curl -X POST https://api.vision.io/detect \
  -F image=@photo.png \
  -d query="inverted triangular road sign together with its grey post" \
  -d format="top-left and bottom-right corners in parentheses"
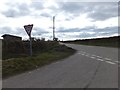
top-left (24, 24), bottom-right (33, 56)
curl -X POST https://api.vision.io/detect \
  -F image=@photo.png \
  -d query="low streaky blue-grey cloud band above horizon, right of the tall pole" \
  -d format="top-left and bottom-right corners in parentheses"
top-left (56, 27), bottom-right (118, 39)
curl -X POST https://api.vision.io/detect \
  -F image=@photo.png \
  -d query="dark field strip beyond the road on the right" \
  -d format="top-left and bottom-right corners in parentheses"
top-left (64, 36), bottom-right (120, 48)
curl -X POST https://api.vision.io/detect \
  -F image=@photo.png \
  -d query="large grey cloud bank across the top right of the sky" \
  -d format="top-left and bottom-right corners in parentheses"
top-left (59, 2), bottom-right (118, 21)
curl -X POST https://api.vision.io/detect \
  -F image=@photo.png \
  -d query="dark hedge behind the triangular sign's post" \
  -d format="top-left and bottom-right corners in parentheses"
top-left (2, 39), bottom-right (58, 60)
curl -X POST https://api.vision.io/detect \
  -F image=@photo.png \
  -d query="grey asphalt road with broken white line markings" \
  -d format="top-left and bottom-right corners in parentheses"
top-left (3, 44), bottom-right (119, 89)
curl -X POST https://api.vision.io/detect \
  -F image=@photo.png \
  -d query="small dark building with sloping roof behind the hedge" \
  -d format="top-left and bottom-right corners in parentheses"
top-left (2, 34), bottom-right (22, 41)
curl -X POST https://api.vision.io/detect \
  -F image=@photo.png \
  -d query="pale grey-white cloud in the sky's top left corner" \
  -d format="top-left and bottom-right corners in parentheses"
top-left (2, 0), bottom-right (43, 18)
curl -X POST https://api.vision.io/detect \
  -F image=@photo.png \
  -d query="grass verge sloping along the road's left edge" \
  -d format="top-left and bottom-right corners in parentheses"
top-left (2, 45), bottom-right (75, 78)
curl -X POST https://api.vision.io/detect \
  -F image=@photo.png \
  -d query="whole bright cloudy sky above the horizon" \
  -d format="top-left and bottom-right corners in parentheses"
top-left (0, 0), bottom-right (118, 40)
